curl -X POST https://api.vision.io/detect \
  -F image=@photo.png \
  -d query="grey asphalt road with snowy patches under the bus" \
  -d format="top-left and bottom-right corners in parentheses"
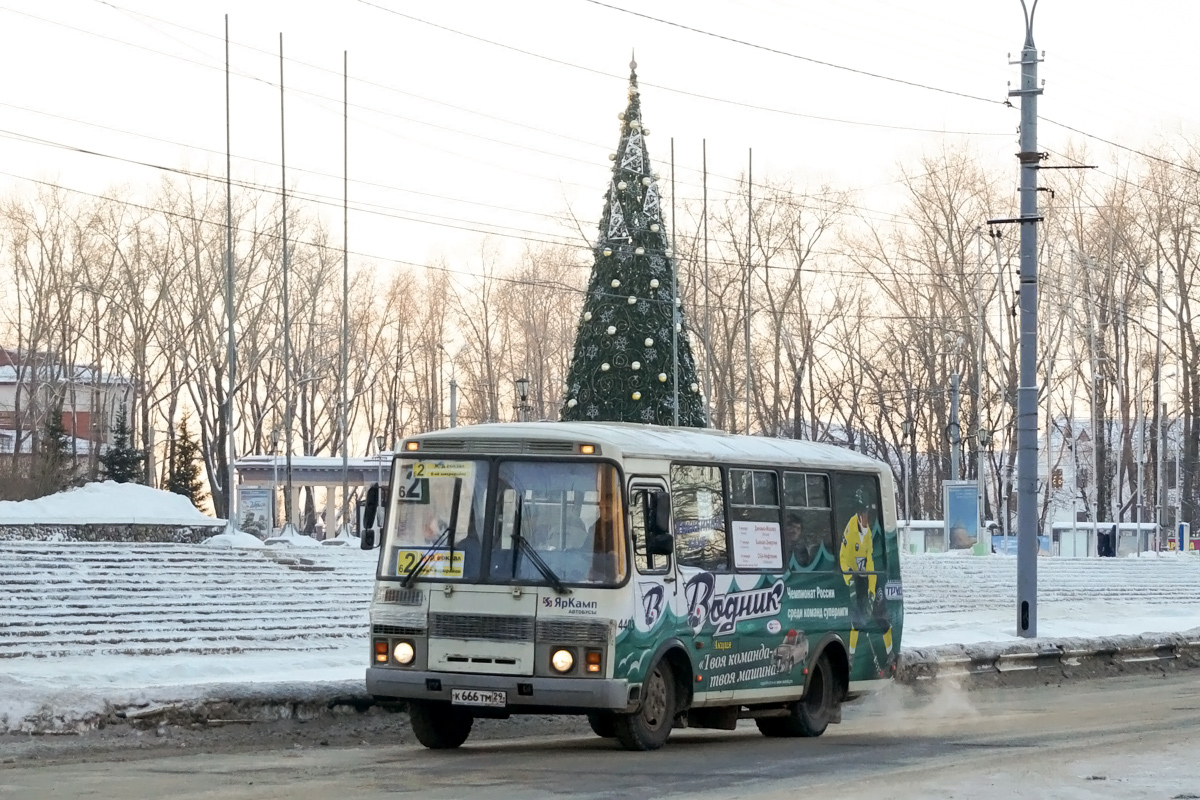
top-left (0, 674), bottom-right (1200, 800)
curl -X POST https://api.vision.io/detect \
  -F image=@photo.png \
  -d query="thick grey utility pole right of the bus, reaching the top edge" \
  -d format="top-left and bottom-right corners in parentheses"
top-left (1008, 0), bottom-right (1042, 638)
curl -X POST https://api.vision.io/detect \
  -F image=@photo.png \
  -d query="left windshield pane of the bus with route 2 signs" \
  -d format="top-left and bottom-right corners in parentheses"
top-left (379, 458), bottom-right (488, 581)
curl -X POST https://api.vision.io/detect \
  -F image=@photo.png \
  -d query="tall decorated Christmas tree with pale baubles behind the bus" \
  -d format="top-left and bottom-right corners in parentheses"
top-left (562, 64), bottom-right (706, 427)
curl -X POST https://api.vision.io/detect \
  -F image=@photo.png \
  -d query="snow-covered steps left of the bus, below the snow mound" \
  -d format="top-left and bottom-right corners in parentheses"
top-left (0, 542), bottom-right (376, 663)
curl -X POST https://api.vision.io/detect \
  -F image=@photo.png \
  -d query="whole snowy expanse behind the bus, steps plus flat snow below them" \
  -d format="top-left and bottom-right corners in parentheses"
top-left (0, 541), bottom-right (1200, 730)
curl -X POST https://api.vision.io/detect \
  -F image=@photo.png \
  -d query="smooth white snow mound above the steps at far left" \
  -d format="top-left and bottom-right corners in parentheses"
top-left (0, 481), bottom-right (224, 527)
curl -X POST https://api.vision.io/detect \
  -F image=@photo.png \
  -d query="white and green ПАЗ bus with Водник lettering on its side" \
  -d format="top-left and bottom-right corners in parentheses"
top-left (362, 422), bottom-right (904, 751)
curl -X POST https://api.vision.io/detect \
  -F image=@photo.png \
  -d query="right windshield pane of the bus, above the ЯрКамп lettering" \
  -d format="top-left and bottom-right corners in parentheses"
top-left (488, 461), bottom-right (626, 585)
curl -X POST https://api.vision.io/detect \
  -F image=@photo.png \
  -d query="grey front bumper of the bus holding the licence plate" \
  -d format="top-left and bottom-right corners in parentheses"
top-left (367, 667), bottom-right (638, 711)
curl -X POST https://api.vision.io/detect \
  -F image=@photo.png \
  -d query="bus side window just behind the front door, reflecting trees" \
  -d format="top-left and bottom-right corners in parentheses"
top-left (671, 464), bottom-right (730, 572)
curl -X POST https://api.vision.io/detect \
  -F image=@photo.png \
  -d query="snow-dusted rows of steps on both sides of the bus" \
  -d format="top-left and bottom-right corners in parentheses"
top-left (0, 542), bottom-right (1200, 673)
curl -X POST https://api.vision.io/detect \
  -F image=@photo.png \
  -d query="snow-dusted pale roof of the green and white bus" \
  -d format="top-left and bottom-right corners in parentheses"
top-left (408, 422), bottom-right (888, 471)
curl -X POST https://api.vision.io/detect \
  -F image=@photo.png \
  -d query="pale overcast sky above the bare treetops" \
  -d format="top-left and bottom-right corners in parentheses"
top-left (0, 0), bottom-right (1200, 272)
